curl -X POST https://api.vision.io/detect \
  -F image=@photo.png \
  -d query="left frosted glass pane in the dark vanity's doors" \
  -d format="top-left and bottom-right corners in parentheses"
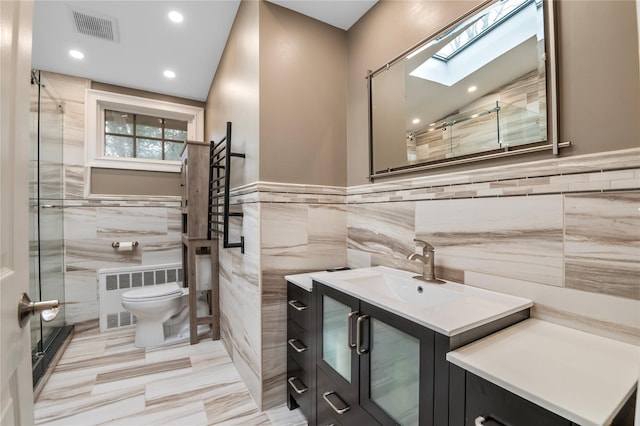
top-left (322, 294), bottom-right (351, 383)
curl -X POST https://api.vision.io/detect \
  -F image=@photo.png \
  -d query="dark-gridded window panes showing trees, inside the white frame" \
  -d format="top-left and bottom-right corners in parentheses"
top-left (104, 109), bottom-right (187, 161)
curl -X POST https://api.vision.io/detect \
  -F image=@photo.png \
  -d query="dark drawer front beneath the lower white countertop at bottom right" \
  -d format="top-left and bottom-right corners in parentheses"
top-left (465, 372), bottom-right (572, 426)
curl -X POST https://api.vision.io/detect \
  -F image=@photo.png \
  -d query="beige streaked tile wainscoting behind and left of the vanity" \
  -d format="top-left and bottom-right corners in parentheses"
top-left (221, 149), bottom-right (640, 409)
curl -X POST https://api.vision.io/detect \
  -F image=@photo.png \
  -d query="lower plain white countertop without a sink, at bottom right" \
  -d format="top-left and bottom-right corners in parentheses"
top-left (447, 319), bottom-right (640, 425)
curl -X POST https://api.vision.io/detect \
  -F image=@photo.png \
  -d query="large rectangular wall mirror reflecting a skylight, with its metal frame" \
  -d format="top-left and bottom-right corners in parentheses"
top-left (368, 0), bottom-right (559, 179)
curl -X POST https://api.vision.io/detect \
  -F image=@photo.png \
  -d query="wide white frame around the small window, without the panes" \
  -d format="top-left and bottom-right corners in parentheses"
top-left (85, 89), bottom-right (204, 173)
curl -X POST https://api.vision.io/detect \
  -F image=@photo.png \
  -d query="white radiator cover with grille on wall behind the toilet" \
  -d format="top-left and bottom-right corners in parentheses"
top-left (98, 263), bottom-right (182, 331)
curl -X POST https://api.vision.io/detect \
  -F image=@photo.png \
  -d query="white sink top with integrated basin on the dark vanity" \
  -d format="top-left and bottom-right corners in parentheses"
top-left (311, 266), bottom-right (533, 336)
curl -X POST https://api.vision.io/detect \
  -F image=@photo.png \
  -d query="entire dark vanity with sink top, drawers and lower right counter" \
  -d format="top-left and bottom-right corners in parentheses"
top-left (287, 267), bottom-right (640, 426)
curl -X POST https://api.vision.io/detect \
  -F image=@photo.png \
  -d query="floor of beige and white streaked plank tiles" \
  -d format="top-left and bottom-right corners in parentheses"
top-left (35, 324), bottom-right (307, 426)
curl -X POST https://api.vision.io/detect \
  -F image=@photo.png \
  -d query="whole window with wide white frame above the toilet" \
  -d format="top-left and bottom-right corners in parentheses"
top-left (85, 89), bottom-right (204, 172)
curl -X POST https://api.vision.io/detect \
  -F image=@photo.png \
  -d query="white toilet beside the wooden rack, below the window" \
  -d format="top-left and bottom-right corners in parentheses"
top-left (121, 282), bottom-right (209, 348)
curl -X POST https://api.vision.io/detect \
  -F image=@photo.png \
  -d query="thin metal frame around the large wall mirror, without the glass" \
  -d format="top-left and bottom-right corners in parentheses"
top-left (365, 0), bottom-right (571, 182)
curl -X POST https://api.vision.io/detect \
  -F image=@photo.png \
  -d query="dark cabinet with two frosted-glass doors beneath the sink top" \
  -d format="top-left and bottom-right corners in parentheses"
top-left (314, 282), bottom-right (529, 426)
